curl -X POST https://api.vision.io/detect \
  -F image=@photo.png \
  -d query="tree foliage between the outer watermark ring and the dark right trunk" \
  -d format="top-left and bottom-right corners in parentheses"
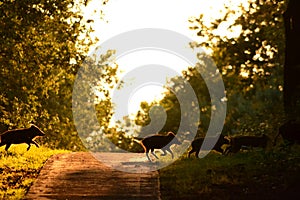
top-left (191, 0), bottom-right (286, 134)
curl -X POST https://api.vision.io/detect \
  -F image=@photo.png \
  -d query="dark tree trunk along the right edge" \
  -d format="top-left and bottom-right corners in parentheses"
top-left (284, 0), bottom-right (300, 119)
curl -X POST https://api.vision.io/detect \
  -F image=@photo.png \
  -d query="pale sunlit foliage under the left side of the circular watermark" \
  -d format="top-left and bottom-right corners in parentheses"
top-left (73, 50), bottom-right (133, 151)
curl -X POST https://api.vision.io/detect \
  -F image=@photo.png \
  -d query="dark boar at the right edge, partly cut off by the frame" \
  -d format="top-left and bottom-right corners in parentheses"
top-left (274, 120), bottom-right (300, 145)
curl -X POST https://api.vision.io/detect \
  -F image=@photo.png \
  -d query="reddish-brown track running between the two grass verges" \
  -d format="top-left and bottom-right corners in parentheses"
top-left (26, 152), bottom-right (160, 200)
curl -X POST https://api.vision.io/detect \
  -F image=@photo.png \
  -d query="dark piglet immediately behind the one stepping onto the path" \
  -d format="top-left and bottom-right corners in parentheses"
top-left (188, 134), bottom-right (229, 158)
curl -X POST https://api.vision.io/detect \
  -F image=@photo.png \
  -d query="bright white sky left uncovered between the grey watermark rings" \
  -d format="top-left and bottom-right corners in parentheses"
top-left (84, 0), bottom-right (247, 121)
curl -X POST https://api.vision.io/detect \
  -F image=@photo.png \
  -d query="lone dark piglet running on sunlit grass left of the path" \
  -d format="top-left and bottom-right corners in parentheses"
top-left (0, 124), bottom-right (45, 151)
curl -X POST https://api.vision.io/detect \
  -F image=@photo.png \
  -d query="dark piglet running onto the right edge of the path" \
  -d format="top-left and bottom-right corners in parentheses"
top-left (141, 132), bottom-right (181, 162)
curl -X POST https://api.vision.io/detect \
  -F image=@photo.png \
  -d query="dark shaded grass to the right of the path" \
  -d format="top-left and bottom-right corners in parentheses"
top-left (159, 145), bottom-right (300, 200)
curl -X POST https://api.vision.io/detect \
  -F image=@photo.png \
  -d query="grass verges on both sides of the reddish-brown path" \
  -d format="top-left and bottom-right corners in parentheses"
top-left (0, 142), bottom-right (300, 200)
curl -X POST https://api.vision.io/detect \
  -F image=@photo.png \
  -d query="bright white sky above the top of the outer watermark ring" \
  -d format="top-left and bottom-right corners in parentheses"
top-left (84, 0), bottom-right (248, 41)
